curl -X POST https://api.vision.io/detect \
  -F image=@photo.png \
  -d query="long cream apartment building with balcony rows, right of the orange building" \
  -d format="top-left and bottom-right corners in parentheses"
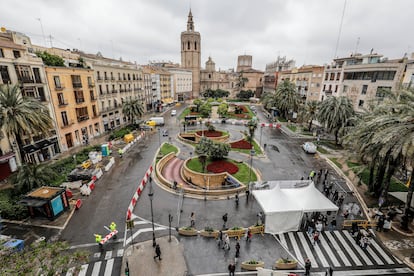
top-left (80, 52), bottom-right (145, 132)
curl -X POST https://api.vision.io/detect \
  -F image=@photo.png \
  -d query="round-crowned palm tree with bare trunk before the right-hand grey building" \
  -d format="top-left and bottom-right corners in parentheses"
top-left (317, 96), bottom-right (355, 145)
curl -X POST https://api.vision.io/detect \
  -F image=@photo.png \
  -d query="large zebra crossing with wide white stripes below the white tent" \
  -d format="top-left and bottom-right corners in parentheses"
top-left (274, 230), bottom-right (404, 270)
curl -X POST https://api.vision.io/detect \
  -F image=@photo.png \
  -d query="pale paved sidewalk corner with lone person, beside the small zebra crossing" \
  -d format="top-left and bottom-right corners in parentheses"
top-left (121, 236), bottom-right (188, 276)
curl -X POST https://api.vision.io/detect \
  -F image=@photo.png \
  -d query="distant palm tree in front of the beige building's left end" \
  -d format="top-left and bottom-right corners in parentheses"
top-left (272, 80), bottom-right (300, 119)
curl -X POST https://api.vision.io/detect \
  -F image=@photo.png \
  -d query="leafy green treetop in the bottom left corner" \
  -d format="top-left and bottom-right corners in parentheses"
top-left (0, 241), bottom-right (88, 276)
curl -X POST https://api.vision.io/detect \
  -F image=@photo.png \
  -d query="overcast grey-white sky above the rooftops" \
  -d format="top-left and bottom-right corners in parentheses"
top-left (0, 0), bottom-right (414, 70)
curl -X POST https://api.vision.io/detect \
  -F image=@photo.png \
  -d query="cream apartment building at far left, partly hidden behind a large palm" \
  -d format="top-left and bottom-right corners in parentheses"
top-left (0, 28), bottom-right (60, 174)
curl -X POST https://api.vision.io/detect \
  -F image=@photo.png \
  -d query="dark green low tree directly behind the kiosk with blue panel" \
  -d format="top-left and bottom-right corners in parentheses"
top-left (10, 163), bottom-right (56, 194)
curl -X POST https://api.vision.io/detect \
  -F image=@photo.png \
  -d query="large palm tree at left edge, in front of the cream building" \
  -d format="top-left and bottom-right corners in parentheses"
top-left (0, 85), bottom-right (52, 164)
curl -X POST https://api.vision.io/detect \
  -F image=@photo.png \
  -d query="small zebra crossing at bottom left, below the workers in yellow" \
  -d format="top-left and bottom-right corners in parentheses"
top-left (66, 249), bottom-right (124, 276)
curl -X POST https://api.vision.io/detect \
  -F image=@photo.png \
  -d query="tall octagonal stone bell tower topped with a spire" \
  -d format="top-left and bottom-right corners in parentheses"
top-left (181, 10), bottom-right (201, 99)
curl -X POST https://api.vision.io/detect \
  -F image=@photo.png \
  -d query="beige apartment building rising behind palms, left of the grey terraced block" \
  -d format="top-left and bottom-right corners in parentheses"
top-left (277, 65), bottom-right (324, 102)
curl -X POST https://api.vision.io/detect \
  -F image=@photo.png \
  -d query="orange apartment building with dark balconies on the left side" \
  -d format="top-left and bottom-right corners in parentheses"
top-left (46, 66), bottom-right (102, 151)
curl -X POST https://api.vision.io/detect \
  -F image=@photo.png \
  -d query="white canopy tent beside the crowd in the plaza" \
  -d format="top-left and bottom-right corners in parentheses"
top-left (253, 181), bottom-right (338, 234)
